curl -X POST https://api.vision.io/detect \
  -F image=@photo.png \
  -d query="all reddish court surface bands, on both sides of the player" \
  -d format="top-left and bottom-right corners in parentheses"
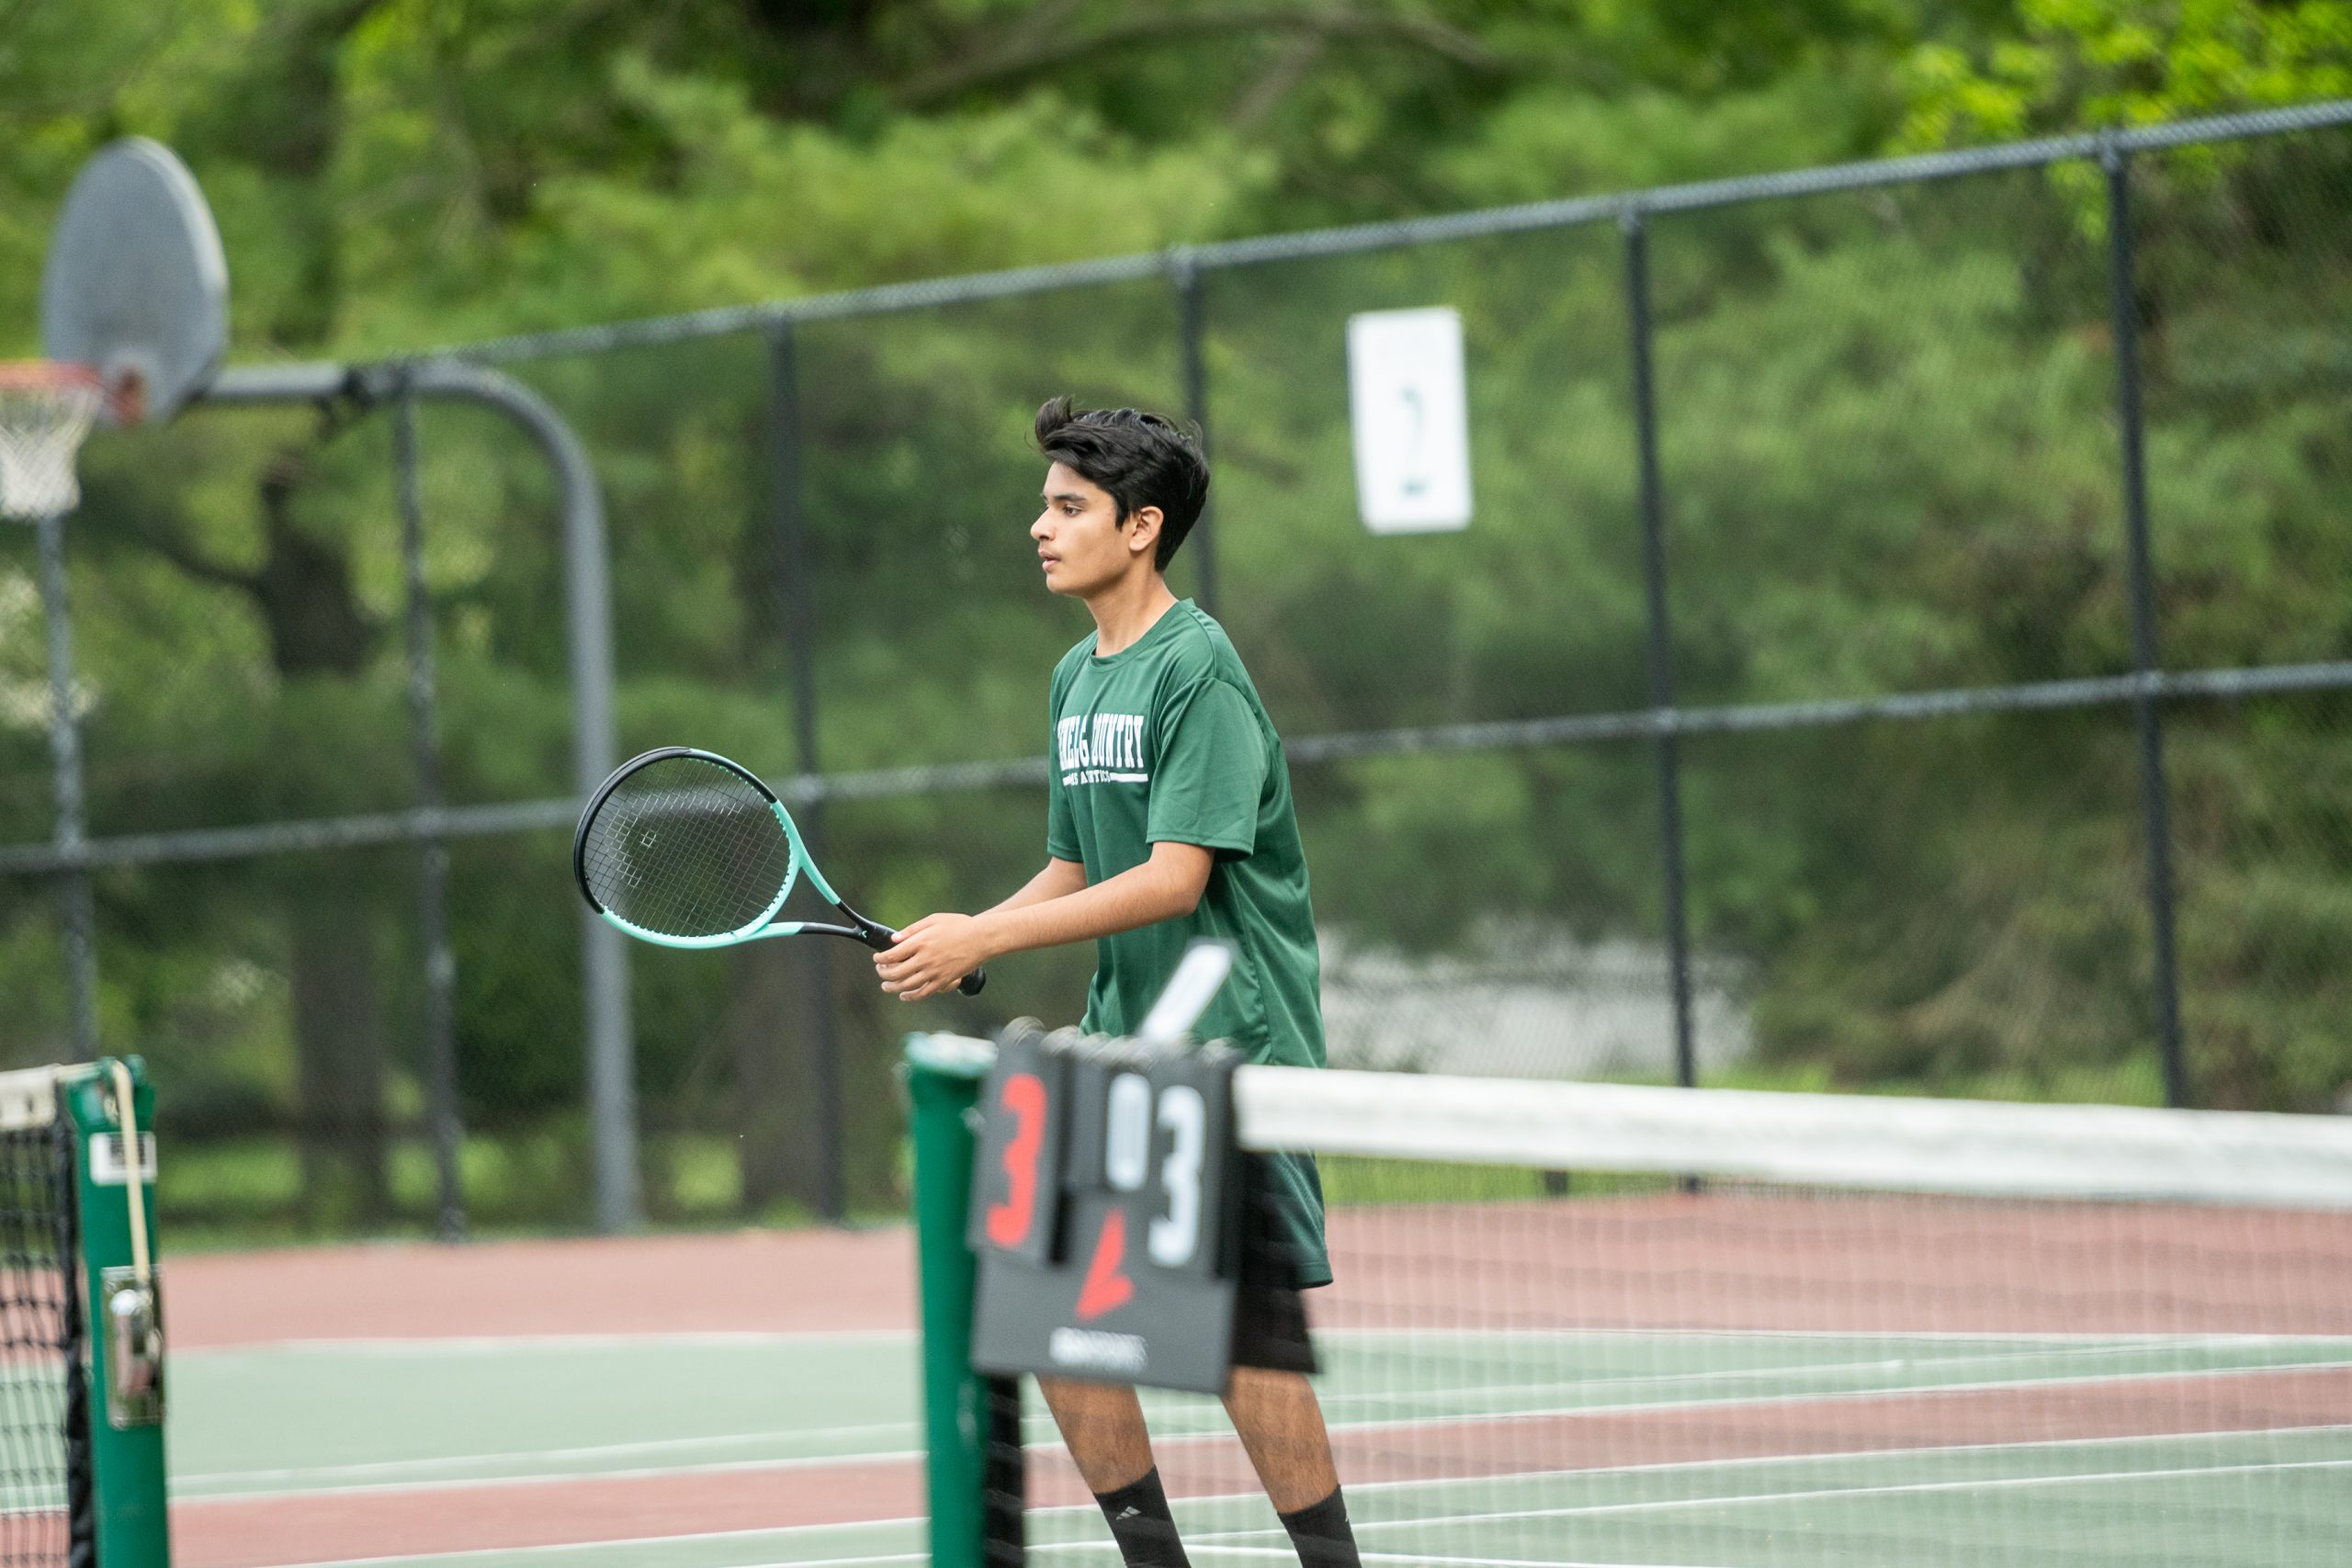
top-left (169, 1194), bottom-right (2352, 1568)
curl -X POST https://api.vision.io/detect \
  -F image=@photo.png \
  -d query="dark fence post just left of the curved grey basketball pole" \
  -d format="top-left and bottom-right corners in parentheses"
top-left (390, 376), bottom-right (466, 1241)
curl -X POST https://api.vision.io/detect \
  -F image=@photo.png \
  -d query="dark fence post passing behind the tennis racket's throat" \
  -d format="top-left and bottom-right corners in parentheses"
top-left (767, 322), bottom-right (849, 1224)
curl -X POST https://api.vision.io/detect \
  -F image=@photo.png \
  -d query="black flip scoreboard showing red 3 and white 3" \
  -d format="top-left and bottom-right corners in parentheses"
top-left (969, 1025), bottom-right (1242, 1394)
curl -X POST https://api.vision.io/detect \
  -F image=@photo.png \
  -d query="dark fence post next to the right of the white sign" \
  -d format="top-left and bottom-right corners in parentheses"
top-left (1623, 207), bottom-right (1698, 1089)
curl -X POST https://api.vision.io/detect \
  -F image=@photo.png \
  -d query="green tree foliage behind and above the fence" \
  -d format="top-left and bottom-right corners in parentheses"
top-left (0, 0), bottom-right (2352, 1224)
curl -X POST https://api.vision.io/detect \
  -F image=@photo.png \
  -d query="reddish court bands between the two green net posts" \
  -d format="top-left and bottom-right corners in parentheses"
top-left (169, 1227), bottom-right (922, 1568)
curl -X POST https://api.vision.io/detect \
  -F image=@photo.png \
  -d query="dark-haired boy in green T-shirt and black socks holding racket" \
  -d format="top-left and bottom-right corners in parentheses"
top-left (875, 398), bottom-right (1360, 1568)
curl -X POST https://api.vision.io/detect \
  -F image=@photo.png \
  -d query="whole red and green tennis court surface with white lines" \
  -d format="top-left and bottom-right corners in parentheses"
top-left (172, 1128), bottom-right (2352, 1568)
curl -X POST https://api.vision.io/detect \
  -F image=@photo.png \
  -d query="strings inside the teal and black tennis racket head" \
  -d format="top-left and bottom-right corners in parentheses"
top-left (581, 757), bottom-right (795, 938)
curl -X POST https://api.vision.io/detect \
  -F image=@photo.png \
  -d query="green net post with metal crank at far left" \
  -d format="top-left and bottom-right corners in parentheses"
top-left (59, 1055), bottom-right (172, 1568)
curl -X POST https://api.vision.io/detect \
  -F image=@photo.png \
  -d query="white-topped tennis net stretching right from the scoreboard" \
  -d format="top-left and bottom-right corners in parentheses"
top-left (922, 1043), bottom-right (2352, 1568)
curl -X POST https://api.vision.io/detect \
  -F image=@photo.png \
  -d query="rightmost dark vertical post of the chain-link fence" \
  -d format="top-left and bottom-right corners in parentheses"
top-left (2098, 141), bottom-right (2189, 1105)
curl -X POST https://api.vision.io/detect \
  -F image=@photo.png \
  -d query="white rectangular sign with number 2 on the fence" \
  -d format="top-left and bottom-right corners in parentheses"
top-left (1348, 306), bottom-right (1470, 534)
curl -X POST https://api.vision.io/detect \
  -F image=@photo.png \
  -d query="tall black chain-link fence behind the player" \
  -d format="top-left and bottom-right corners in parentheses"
top-left (0, 104), bottom-right (2352, 1236)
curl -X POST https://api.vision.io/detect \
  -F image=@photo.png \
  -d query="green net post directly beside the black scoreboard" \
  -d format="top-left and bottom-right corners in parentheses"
top-left (906, 1034), bottom-right (990, 1568)
